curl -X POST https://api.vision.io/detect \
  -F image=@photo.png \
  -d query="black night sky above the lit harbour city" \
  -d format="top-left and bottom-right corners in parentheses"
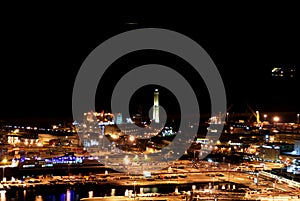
top-left (0, 6), bottom-right (300, 124)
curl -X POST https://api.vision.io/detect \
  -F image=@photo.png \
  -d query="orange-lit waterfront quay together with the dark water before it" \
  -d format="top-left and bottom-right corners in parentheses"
top-left (1, 161), bottom-right (299, 201)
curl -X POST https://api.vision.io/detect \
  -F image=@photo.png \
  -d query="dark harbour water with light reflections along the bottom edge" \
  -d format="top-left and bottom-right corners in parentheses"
top-left (0, 182), bottom-right (245, 201)
